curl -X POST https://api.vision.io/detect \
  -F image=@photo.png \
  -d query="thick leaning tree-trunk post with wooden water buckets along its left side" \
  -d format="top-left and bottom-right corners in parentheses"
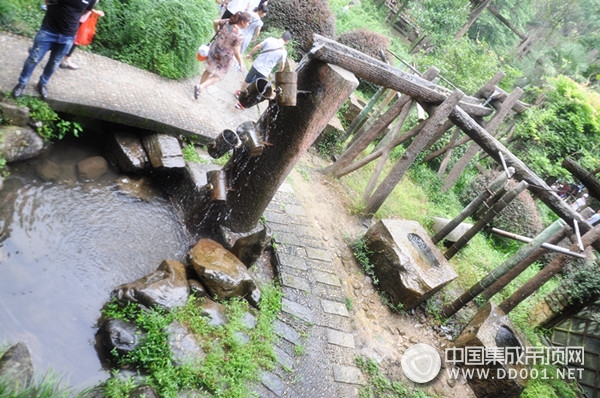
top-left (202, 58), bottom-right (358, 236)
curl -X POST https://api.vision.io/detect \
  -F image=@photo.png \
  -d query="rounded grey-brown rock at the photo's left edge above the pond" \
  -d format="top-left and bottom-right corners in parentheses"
top-left (0, 126), bottom-right (44, 163)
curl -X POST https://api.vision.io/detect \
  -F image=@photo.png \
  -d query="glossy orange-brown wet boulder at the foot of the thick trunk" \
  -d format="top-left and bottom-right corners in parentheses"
top-left (189, 239), bottom-right (257, 300)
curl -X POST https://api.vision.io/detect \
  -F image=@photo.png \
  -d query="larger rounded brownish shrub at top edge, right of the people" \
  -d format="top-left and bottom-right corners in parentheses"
top-left (265, 0), bottom-right (335, 52)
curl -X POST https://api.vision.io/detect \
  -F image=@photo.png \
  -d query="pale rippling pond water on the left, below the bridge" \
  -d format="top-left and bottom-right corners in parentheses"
top-left (0, 134), bottom-right (188, 388)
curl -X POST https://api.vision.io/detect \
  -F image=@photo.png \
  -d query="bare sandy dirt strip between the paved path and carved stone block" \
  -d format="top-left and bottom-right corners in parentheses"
top-left (288, 153), bottom-right (474, 398)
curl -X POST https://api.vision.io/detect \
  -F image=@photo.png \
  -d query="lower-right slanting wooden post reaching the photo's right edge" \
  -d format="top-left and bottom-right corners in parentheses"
top-left (500, 225), bottom-right (600, 314)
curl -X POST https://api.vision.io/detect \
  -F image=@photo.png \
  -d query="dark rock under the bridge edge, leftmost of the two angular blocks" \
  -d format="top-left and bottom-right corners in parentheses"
top-left (108, 132), bottom-right (150, 173)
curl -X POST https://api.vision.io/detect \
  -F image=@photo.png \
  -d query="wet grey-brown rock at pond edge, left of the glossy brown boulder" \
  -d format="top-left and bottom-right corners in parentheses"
top-left (111, 260), bottom-right (189, 310)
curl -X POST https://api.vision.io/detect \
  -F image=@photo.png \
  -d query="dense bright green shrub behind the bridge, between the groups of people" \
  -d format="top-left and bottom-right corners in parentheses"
top-left (92, 0), bottom-right (218, 79)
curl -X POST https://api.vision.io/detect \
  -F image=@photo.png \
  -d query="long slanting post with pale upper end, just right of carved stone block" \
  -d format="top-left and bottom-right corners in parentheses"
top-left (442, 219), bottom-right (566, 318)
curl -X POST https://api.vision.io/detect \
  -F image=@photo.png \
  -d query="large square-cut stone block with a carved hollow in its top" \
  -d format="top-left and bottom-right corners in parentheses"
top-left (365, 220), bottom-right (457, 310)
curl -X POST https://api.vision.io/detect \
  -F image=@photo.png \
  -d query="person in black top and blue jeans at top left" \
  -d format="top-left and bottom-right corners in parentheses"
top-left (12, 0), bottom-right (96, 99)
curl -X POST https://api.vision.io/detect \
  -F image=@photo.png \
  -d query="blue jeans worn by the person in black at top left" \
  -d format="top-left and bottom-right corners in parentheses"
top-left (19, 29), bottom-right (75, 86)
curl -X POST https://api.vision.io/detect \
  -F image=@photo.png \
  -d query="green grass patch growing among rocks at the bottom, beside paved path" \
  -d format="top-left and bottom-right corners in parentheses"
top-left (98, 285), bottom-right (281, 398)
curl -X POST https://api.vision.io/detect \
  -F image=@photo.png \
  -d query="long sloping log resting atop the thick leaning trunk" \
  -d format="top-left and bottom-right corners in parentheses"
top-left (308, 34), bottom-right (492, 117)
